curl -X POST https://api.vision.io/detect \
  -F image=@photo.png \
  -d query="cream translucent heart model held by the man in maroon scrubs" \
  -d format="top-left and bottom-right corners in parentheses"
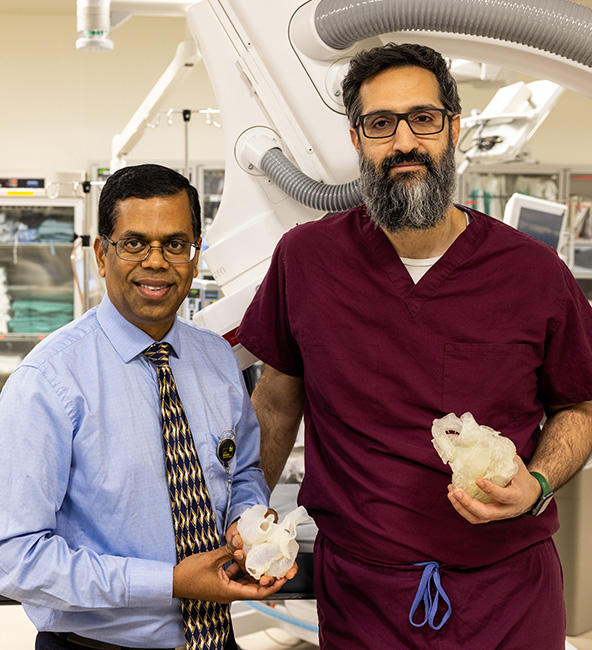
top-left (432, 413), bottom-right (518, 503)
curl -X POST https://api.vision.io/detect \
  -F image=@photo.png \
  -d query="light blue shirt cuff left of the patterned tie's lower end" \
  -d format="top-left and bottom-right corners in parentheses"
top-left (127, 558), bottom-right (173, 607)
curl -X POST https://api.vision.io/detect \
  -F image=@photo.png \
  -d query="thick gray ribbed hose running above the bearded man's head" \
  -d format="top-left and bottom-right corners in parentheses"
top-left (315, 0), bottom-right (592, 67)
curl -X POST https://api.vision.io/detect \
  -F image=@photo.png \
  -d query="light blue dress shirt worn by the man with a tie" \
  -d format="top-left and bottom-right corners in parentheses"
top-left (0, 297), bottom-right (269, 648)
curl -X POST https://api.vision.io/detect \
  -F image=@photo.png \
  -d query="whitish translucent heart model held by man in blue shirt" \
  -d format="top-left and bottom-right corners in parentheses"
top-left (238, 505), bottom-right (308, 580)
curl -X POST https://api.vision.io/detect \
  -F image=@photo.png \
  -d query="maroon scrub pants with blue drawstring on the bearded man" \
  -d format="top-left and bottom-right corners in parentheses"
top-left (314, 533), bottom-right (565, 650)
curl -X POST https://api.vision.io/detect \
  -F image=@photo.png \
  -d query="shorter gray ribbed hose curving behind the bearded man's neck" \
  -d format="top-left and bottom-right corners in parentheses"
top-left (261, 148), bottom-right (362, 212)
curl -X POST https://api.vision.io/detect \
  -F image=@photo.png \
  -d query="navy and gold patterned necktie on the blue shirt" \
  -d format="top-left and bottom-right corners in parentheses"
top-left (144, 343), bottom-right (230, 650)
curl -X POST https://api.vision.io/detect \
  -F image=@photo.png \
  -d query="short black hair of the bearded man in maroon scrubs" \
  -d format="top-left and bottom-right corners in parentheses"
top-left (343, 43), bottom-right (461, 128)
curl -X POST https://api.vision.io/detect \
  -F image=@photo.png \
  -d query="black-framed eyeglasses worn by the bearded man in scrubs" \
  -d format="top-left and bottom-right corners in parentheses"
top-left (358, 108), bottom-right (452, 138)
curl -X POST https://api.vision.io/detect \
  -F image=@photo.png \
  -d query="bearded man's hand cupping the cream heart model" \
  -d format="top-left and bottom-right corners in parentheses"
top-left (448, 456), bottom-right (541, 524)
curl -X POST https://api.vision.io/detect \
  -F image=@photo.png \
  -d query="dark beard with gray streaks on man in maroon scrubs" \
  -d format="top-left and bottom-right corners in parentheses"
top-left (358, 141), bottom-right (456, 233)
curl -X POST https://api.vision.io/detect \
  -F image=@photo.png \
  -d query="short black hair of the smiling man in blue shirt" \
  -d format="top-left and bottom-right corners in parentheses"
top-left (99, 164), bottom-right (201, 242)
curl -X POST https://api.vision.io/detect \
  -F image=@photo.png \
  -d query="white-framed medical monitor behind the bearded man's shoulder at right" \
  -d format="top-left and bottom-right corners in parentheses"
top-left (504, 193), bottom-right (567, 251)
